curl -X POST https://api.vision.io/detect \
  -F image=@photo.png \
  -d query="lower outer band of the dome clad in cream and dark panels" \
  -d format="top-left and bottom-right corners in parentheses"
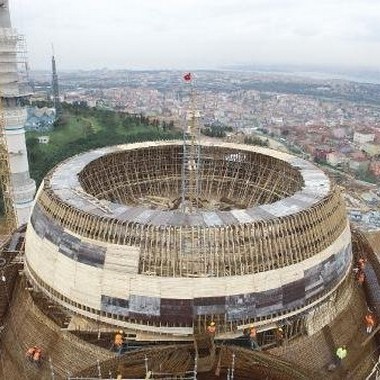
top-left (26, 202), bottom-right (352, 336)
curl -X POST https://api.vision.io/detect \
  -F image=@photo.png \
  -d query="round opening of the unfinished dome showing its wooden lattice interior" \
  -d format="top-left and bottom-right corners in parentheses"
top-left (78, 145), bottom-right (304, 211)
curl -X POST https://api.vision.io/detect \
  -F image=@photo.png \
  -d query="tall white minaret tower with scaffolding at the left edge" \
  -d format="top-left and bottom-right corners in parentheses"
top-left (0, 0), bottom-right (36, 226)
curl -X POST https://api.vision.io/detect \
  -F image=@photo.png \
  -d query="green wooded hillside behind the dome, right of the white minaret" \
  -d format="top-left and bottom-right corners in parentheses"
top-left (26, 105), bottom-right (181, 185)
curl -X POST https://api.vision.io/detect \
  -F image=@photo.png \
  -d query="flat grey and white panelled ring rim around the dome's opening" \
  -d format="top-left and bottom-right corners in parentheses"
top-left (45, 141), bottom-right (331, 227)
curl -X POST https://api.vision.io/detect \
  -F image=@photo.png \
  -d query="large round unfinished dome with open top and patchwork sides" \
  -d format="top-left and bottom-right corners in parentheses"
top-left (25, 141), bottom-right (352, 339)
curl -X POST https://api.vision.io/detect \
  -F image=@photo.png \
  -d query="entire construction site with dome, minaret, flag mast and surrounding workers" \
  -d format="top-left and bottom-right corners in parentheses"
top-left (0, 1), bottom-right (380, 380)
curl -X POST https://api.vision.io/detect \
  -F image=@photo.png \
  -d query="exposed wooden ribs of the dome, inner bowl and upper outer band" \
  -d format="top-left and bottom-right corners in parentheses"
top-left (34, 145), bottom-right (347, 277)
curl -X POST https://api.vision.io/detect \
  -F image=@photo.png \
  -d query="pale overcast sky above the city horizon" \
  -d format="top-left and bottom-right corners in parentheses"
top-left (10, 0), bottom-right (380, 69)
